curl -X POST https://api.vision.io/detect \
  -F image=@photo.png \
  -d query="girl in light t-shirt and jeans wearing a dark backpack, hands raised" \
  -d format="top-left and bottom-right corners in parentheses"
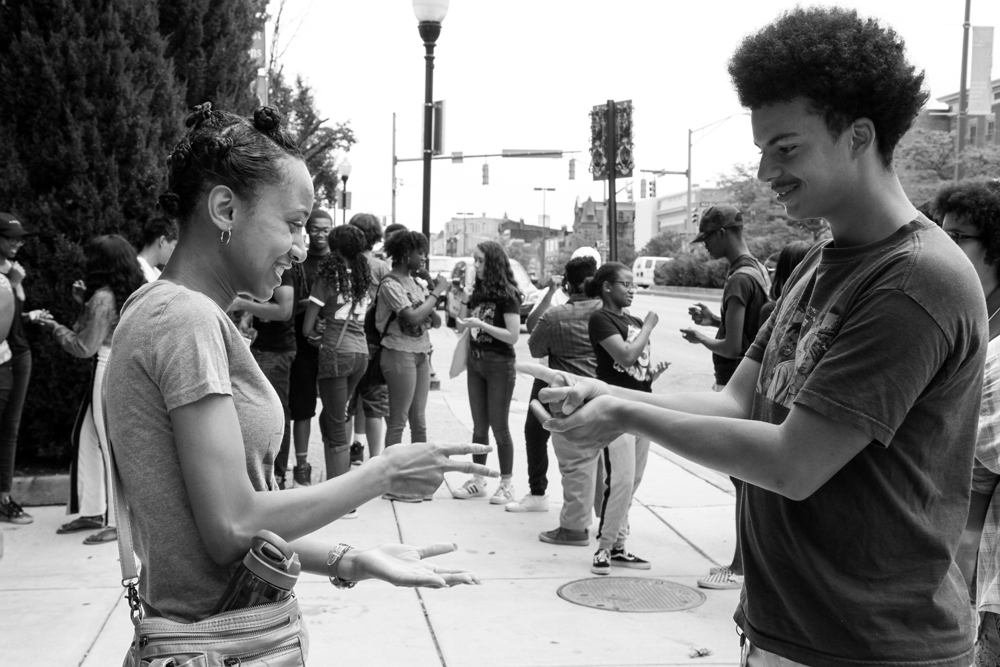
top-left (375, 231), bottom-right (448, 482)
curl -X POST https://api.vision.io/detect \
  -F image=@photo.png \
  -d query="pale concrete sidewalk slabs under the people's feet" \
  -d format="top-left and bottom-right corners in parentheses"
top-left (0, 332), bottom-right (739, 667)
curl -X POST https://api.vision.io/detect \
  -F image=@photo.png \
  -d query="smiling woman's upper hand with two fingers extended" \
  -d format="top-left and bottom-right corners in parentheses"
top-left (374, 442), bottom-right (500, 495)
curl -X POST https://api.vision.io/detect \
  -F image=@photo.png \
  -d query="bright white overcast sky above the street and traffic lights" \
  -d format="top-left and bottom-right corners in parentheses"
top-left (269, 0), bottom-right (1000, 232)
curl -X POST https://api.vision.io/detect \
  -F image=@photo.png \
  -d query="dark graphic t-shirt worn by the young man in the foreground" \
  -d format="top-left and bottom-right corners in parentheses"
top-left (735, 216), bottom-right (988, 667)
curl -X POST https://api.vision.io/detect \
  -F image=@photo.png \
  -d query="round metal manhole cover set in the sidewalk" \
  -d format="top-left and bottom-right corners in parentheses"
top-left (558, 577), bottom-right (705, 612)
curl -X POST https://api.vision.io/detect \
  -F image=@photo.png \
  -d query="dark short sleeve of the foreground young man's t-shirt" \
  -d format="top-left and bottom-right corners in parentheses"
top-left (796, 289), bottom-right (952, 446)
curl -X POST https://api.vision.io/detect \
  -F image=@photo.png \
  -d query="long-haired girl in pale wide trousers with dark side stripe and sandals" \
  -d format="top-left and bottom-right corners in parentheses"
top-left (38, 234), bottom-right (146, 544)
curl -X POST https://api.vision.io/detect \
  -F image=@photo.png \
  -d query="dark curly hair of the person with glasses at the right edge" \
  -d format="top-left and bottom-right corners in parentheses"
top-left (932, 178), bottom-right (1000, 277)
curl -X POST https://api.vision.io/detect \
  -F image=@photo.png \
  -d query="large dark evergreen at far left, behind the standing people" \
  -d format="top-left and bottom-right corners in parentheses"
top-left (0, 0), bottom-right (181, 457)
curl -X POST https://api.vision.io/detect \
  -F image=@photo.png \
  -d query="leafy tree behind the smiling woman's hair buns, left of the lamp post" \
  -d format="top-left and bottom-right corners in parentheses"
top-left (268, 70), bottom-right (356, 208)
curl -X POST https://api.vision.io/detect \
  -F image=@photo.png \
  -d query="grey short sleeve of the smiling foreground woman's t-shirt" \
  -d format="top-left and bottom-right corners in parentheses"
top-left (151, 296), bottom-right (234, 411)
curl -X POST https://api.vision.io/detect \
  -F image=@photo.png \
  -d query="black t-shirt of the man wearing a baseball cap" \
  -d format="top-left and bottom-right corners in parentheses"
top-left (712, 255), bottom-right (770, 385)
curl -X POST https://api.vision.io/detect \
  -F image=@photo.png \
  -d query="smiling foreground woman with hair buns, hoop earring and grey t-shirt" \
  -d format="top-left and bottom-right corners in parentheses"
top-left (105, 104), bottom-right (494, 636)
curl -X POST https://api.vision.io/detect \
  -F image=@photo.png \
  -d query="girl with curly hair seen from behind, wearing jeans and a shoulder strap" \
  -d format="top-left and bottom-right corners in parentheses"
top-left (302, 225), bottom-right (372, 490)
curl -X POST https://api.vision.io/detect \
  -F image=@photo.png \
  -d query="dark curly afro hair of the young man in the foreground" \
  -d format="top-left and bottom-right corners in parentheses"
top-left (729, 7), bottom-right (929, 169)
